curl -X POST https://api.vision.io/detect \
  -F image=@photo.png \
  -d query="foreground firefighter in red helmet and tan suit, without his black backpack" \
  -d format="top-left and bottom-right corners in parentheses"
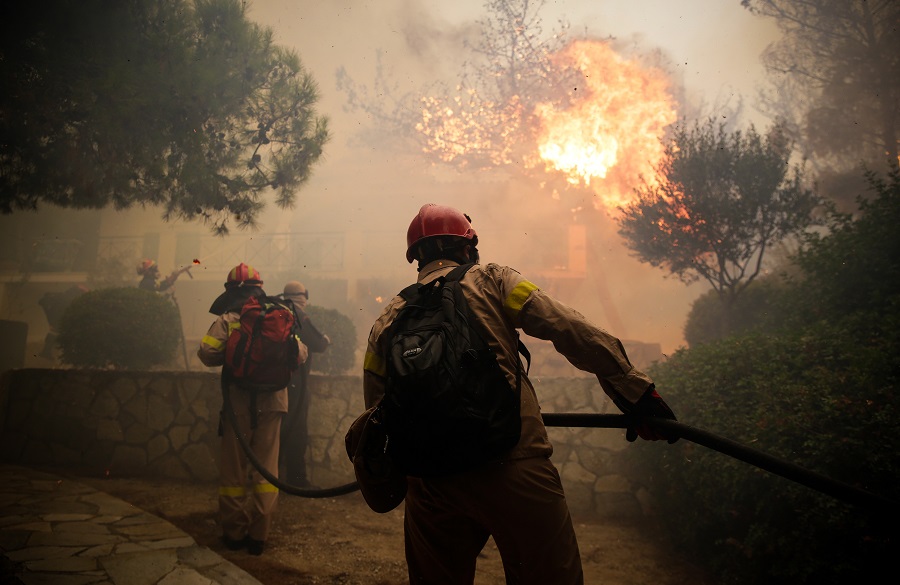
top-left (363, 204), bottom-right (676, 585)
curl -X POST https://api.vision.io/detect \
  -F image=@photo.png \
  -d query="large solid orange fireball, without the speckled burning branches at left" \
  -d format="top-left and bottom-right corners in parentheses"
top-left (535, 41), bottom-right (677, 208)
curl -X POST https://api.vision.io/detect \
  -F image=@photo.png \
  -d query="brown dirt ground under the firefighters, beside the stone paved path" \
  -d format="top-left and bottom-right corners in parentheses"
top-left (73, 477), bottom-right (714, 585)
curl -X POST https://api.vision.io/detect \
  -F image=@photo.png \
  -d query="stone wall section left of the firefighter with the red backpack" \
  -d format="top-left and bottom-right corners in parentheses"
top-left (0, 369), bottom-right (221, 481)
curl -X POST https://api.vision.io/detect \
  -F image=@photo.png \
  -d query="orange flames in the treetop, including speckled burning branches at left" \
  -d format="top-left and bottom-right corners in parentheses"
top-left (416, 40), bottom-right (677, 210)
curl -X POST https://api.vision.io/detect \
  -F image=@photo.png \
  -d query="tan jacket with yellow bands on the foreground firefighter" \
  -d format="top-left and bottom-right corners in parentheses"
top-left (363, 260), bottom-right (652, 459)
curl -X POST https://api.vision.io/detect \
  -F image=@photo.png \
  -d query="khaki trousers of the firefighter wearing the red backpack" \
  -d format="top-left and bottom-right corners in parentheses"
top-left (219, 409), bottom-right (284, 541)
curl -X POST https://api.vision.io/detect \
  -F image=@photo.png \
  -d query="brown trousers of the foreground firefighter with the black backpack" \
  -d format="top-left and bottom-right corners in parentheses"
top-left (404, 457), bottom-right (584, 585)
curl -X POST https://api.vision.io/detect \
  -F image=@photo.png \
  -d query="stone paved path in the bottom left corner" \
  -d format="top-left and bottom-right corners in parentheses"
top-left (0, 465), bottom-right (261, 585)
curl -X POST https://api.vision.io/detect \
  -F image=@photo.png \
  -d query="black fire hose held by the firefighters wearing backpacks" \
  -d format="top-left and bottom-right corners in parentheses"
top-left (222, 384), bottom-right (900, 518)
